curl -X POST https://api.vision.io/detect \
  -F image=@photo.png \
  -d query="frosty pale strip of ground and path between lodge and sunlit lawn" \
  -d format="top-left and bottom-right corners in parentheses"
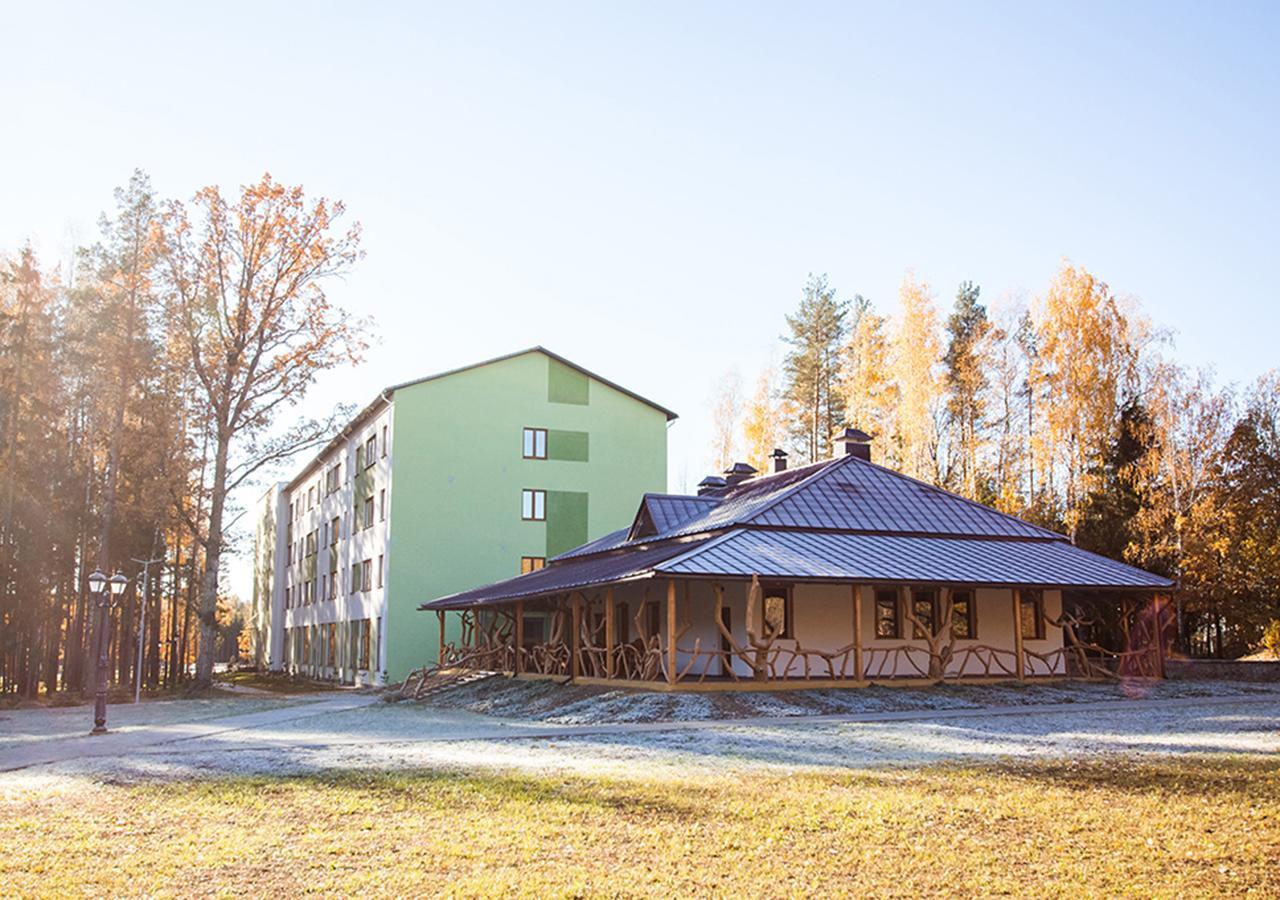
top-left (0, 685), bottom-right (1280, 794)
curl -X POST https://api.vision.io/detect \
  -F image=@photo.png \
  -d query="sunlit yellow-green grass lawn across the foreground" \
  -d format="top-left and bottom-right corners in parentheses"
top-left (0, 758), bottom-right (1280, 896)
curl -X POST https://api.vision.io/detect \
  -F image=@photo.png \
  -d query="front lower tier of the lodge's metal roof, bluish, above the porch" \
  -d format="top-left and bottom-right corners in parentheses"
top-left (654, 529), bottom-right (1172, 590)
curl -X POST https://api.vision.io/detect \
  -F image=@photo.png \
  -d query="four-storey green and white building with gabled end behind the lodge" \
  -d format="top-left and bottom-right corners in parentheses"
top-left (253, 347), bottom-right (676, 684)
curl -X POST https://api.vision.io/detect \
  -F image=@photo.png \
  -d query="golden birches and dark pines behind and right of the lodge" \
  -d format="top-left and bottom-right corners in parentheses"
top-left (713, 262), bottom-right (1280, 657)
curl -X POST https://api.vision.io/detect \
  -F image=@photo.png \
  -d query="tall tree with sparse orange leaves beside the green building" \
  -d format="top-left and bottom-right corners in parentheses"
top-left (161, 174), bottom-right (367, 685)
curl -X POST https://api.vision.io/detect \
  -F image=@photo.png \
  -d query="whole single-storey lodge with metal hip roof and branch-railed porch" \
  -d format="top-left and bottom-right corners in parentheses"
top-left (422, 429), bottom-right (1172, 690)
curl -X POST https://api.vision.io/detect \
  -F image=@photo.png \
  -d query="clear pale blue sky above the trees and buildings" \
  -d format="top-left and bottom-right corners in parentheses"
top-left (0, 3), bottom-right (1280, 599)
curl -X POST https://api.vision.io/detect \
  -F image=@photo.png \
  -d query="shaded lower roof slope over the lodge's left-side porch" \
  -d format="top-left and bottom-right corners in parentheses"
top-left (419, 538), bottom-right (709, 609)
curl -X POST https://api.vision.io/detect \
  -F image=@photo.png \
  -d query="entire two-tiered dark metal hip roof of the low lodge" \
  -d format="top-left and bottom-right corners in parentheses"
top-left (422, 454), bottom-right (1172, 609)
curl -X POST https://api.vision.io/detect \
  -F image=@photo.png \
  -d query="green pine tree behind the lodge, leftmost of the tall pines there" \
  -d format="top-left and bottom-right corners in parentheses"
top-left (783, 275), bottom-right (847, 462)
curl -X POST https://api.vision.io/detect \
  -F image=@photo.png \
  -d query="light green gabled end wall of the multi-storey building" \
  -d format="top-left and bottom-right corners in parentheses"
top-left (384, 352), bottom-right (667, 681)
